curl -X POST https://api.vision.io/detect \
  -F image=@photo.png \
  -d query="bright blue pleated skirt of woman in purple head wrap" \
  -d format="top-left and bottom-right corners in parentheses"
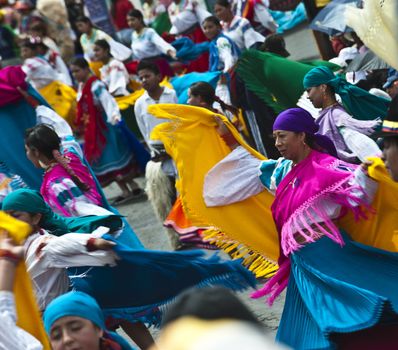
top-left (277, 232), bottom-right (398, 349)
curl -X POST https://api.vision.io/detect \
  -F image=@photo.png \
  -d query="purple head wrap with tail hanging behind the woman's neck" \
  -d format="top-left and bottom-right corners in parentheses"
top-left (272, 108), bottom-right (337, 158)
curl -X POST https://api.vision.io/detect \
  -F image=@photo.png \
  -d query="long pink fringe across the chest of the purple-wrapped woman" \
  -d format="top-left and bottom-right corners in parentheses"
top-left (281, 176), bottom-right (371, 256)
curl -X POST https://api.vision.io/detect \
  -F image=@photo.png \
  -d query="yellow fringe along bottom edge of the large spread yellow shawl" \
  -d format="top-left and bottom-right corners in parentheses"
top-left (201, 228), bottom-right (278, 278)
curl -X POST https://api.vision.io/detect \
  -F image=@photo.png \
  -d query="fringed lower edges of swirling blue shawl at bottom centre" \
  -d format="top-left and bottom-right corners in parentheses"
top-left (102, 271), bottom-right (254, 328)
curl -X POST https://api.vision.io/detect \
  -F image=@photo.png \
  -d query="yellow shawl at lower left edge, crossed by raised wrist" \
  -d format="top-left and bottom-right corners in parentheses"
top-left (0, 211), bottom-right (51, 350)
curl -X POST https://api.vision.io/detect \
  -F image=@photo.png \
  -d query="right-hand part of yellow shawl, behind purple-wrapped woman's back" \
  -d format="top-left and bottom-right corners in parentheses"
top-left (339, 158), bottom-right (398, 252)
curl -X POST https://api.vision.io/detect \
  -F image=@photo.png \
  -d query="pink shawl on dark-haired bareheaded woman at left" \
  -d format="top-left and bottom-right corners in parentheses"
top-left (40, 152), bottom-right (103, 216)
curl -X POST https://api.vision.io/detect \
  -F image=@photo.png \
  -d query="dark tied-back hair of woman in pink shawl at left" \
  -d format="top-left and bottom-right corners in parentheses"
top-left (25, 124), bottom-right (90, 192)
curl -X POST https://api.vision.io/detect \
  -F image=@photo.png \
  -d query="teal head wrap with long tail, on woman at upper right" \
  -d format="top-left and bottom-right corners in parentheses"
top-left (303, 66), bottom-right (389, 120)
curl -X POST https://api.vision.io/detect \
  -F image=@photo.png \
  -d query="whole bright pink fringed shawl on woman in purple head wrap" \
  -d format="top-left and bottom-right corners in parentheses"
top-left (252, 151), bottom-right (367, 304)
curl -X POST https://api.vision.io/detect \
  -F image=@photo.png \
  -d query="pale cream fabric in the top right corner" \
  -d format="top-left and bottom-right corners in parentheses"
top-left (342, 0), bottom-right (398, 69)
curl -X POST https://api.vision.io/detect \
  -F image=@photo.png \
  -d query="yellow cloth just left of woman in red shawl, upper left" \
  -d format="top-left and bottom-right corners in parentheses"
top-left (39, 81), bottom-right (77, 128)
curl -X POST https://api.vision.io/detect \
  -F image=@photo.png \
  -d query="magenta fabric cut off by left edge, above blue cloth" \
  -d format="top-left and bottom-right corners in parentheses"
top-left (0, 66), bottom-right (28, 107)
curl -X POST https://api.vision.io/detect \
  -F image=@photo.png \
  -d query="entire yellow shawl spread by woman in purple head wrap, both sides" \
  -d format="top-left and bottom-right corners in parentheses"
top-left (148, 104), bottom-right (398, 277)
